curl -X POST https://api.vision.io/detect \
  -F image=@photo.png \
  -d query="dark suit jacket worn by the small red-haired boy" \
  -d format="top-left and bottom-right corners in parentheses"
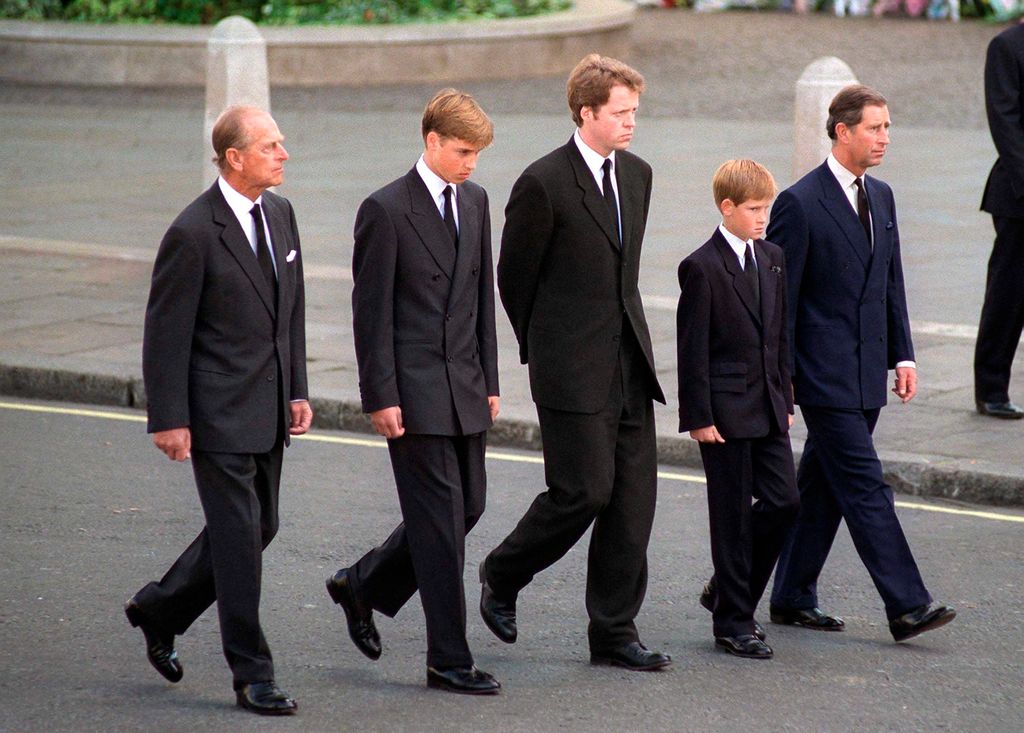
top-left (676, 229), bottom-right (793, 440)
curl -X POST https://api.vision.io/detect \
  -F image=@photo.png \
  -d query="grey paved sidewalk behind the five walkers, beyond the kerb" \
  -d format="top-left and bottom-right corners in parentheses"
top-left (0, 12), bottom-right (1024, 505)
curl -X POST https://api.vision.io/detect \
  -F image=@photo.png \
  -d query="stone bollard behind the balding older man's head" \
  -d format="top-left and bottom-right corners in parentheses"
top-left (203, 15), bottom-right (270, 188)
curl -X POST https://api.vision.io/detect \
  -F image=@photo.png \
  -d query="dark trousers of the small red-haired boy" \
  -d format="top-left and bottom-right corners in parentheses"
top-left (700, 433), bottom-right (800, 637)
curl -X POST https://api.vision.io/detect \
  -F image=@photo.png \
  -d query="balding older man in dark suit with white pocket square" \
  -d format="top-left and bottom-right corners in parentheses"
top-left (125, 106), bottom-right (312, 715)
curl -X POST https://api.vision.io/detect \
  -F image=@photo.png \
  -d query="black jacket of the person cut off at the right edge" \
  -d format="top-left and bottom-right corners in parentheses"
top-left (981, 25), bottom-right (1024, 219)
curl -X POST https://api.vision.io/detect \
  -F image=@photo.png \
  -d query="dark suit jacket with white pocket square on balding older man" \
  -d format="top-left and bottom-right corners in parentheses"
top-left (142, 182), bottom-right (308, 454)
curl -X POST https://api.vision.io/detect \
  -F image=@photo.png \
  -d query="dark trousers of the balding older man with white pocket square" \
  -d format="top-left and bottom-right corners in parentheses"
top-left (135, 437), bottom-right (284, 689)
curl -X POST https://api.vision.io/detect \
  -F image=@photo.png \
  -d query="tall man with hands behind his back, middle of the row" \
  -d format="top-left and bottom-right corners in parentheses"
top-left (480, 53), bottom-right (671, 670)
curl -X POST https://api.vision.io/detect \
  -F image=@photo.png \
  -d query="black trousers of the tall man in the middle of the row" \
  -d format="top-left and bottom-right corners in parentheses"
top-left (484, 329), bottom-right (657, 651)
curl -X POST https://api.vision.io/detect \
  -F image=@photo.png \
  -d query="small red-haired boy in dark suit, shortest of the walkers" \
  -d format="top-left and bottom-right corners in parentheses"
top-left (676, 160), bottom-right (800, 659)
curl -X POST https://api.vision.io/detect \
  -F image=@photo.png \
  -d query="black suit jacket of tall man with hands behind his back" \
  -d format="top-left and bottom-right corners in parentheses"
top-left (498, 139), bottom-right (665, 413)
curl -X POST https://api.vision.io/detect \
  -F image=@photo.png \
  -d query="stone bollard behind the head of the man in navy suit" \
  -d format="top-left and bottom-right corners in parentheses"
top-left (793, 56), bottom-right (857, 179)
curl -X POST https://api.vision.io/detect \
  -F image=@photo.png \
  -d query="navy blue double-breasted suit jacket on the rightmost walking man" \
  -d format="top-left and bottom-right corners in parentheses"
top-left (767, 163), bottom-right (913, 409)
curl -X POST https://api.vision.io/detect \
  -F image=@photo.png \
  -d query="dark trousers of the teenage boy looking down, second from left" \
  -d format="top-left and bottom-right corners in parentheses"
top-left (350, 433), bottom-right (486, 666)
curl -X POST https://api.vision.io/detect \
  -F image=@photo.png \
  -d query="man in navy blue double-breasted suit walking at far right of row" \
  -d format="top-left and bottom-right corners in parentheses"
top-left (768, 84), bottom-right (956, 642)
